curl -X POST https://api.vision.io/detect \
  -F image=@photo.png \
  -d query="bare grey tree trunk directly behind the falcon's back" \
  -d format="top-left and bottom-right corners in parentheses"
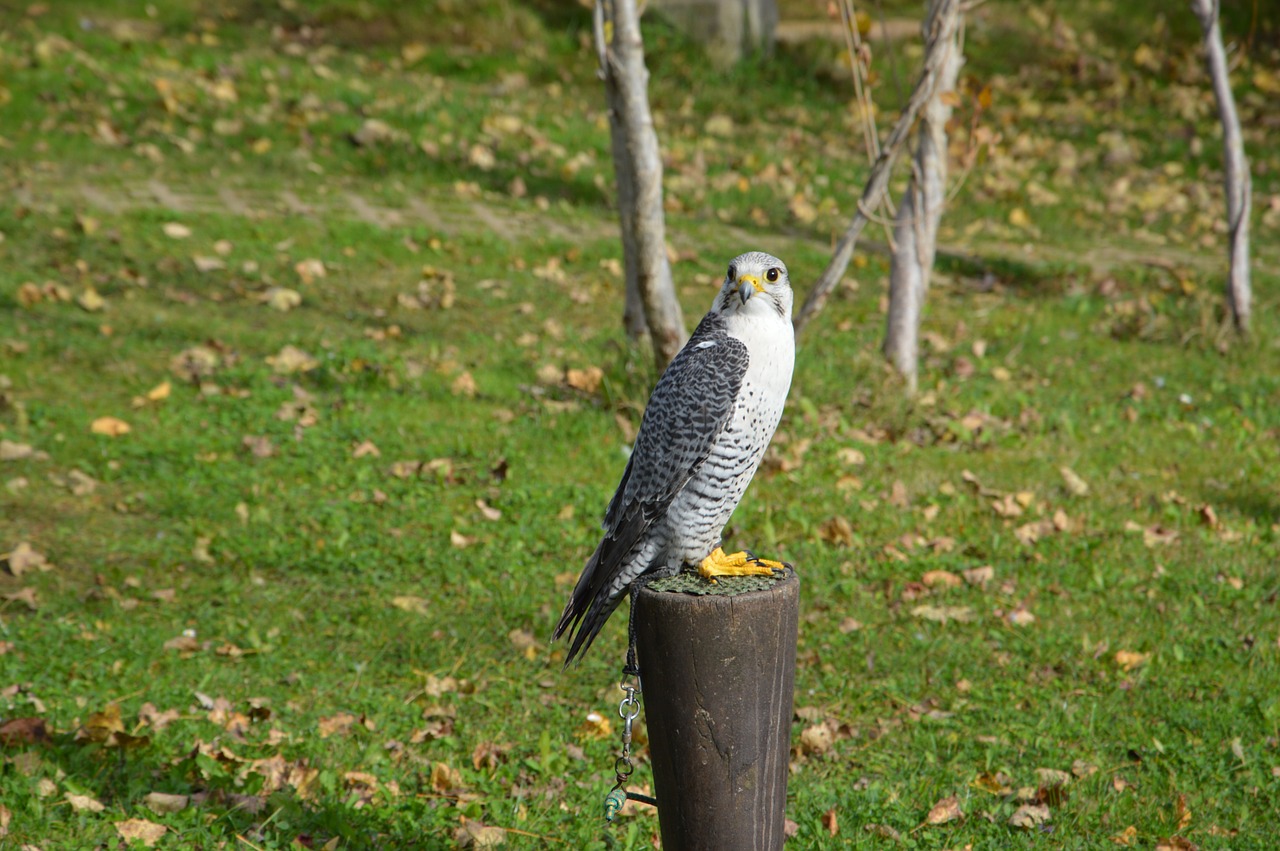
top-left (595, 0), bottom-right (687, 370)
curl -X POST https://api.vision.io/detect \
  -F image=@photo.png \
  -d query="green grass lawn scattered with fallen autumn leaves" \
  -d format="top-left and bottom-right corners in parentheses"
top-left (0, 0), bottom-right (1280, 850)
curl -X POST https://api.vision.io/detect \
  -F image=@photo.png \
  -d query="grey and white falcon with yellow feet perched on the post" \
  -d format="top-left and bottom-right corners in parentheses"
top-left (552, 251), bottom-right (795, 667)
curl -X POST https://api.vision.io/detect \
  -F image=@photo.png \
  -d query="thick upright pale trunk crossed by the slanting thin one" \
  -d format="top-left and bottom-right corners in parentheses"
top-left (884, 0), bottom-right (964, 393)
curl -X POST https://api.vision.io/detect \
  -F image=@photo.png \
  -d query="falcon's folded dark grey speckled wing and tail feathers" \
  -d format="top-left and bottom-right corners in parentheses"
top-left (553, 315), bottom-right (750, 667)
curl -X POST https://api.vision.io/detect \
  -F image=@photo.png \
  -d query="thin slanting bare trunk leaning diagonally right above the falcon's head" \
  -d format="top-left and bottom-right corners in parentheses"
top-left (795, 0), bottom-right (960, 334)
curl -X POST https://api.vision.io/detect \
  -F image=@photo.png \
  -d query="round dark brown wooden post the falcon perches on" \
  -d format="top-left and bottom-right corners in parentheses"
top-left (635, 571), bottom-right (800, 851)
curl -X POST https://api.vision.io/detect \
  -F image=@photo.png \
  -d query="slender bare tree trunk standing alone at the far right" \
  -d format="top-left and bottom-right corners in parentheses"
top-left (1192, 0), bottom-right (1253, 334)
